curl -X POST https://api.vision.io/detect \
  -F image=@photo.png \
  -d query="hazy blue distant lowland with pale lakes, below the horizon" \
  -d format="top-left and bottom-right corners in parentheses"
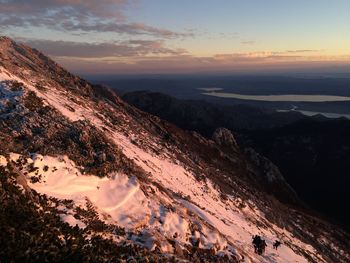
top-left (87, 76), bottom-right (350, 118)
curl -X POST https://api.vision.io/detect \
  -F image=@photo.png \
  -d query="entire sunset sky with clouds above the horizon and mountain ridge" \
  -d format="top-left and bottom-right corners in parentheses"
top-left (0, 0), bottom-right (350, 75)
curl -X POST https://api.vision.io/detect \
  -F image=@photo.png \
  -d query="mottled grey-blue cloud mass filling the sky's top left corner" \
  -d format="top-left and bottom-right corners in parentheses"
top-left (0, 0), bottom-right (194, 38)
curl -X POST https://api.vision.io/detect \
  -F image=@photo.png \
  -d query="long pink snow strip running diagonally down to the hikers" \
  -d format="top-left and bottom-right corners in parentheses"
top-left (104, 130), bottom-right (315, 262)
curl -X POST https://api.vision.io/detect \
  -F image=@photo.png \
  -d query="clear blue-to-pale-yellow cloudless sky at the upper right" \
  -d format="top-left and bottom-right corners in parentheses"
top-left (128, 0), bottom-right (350, 53)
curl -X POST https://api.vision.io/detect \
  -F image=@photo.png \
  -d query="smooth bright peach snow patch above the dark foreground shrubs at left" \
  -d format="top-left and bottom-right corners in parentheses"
top-left (11, 155), bottom-right (149, 231)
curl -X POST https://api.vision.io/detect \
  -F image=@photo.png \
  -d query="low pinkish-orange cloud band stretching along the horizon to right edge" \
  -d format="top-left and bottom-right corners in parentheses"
top-left (50, 49), bottom-right (350, 75)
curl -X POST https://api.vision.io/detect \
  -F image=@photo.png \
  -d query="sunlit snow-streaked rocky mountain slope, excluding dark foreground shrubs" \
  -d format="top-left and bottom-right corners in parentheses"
top-left (0, 37), bottom-right (350, 262)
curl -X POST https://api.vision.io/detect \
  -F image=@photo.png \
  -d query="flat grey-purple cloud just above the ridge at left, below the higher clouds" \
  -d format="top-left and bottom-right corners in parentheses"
top-left (22, 39), bottom-right (186, 58)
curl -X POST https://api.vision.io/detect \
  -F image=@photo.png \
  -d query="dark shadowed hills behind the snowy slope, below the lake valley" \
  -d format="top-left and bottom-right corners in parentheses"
top-left (122, 91), bottom-right (350, 230)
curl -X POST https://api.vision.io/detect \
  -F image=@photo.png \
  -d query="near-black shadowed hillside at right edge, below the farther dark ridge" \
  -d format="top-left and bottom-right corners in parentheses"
top-left (240, 119), bottom-right (350, 230)
